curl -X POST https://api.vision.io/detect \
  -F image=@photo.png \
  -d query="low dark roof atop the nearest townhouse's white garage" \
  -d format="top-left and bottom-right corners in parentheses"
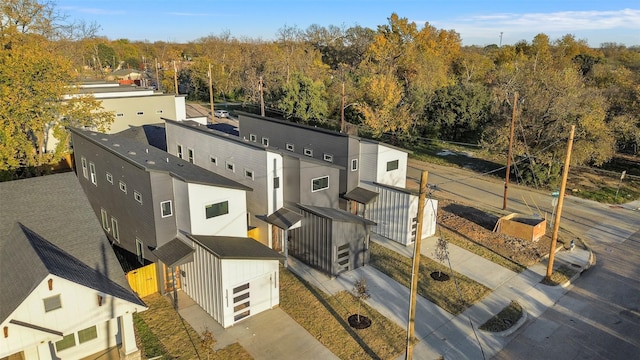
top-left (187, 235), bottom-right (284, 260)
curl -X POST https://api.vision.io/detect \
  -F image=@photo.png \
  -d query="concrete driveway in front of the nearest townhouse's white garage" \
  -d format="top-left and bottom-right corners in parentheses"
top-left (178, 291), bottom-right (338, 360)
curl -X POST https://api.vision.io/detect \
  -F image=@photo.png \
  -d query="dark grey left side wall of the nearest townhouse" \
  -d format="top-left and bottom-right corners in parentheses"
top-left (73, 135), bottom-right (166, 261)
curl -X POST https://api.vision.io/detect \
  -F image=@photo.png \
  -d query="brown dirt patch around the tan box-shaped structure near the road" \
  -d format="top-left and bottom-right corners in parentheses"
top-left (437, 200), bottom-right (551, 267)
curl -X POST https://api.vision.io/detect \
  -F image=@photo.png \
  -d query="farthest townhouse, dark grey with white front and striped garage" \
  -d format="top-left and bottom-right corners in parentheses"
top-left (238, 112), bottom-right (437, 245)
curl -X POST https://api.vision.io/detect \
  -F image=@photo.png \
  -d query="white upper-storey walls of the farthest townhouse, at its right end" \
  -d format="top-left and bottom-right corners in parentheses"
top-left (360, 140), bottom-right (407, 188)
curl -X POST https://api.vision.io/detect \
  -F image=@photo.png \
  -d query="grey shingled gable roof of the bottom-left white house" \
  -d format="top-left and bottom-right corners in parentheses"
top-left (0, 173), bottom-right (144, 321)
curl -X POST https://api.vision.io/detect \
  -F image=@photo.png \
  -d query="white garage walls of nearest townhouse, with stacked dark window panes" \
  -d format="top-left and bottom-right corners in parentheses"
top-left (182, 242), bottom-right (280, 328)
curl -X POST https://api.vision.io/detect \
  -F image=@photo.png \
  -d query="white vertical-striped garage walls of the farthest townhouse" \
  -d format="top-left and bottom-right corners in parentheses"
top-left (366, 184), bottom-right (438, 245)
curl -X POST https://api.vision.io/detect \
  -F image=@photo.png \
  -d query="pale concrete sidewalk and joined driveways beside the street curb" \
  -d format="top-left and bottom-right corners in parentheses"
top-left (289, 232), bottom-right (592, 359)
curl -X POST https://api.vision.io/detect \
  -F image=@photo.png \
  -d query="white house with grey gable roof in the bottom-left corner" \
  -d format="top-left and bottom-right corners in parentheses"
top-left (0, 173), bottom-right (147, 360)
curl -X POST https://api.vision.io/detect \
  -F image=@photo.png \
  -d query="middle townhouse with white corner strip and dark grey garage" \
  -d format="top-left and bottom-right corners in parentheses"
top-left (165, 119), bottom-right (372, 275)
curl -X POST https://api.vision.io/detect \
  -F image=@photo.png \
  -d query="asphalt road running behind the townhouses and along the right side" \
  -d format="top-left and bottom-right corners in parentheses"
top-left (408, 161), bottom-right (640, 360)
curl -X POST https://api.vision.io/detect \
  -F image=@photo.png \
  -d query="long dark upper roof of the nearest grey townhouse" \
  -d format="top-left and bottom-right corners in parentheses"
top-left (70, 128), bottom-right (253, 191)
